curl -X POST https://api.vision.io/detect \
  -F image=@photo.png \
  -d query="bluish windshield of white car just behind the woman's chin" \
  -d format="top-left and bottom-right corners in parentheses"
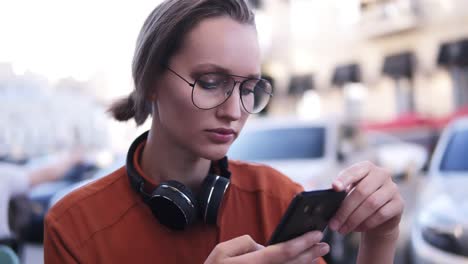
top-left (228, 127), bottom-right (325, 161)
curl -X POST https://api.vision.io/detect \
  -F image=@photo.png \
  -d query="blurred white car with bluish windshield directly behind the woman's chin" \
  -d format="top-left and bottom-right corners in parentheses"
top-left (228, 118), bottom-right (341, 189)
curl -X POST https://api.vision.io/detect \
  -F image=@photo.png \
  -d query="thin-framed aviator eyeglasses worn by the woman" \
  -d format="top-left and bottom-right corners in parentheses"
top-left (167, 67), bottom-right (273, 114)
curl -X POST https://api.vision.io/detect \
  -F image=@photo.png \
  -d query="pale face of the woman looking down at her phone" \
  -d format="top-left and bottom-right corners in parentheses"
top-left (153, 17), bottom-right (260, 160)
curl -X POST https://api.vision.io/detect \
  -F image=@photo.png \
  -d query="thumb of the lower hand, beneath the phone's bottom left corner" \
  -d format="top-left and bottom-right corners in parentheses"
top-left (215, 235), bottom-right (263, 257)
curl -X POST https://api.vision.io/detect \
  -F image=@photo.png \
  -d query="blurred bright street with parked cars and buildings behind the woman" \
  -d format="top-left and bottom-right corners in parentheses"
top-left (0, 0), bottom-right (468, 264)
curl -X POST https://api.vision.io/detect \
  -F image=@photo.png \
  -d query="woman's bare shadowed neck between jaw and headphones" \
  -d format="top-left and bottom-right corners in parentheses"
top-left (141, 128), bottom-right (211, 193)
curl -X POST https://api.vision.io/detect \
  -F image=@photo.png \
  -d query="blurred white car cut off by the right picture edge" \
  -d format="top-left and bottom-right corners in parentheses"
top-left (411, 118), bottom-right (468, 264)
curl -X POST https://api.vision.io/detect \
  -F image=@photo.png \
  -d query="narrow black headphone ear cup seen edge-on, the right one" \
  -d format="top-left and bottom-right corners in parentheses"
top-left (198, 174), bottom-right (229, 225)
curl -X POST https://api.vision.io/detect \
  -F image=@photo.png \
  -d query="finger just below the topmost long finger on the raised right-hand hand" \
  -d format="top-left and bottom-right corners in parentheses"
top-left (339, 180), bottom-right (398, 234)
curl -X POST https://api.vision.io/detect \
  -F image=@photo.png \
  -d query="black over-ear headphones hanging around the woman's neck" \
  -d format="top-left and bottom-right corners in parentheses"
top-left (126, 131), bottom-right (231, 230)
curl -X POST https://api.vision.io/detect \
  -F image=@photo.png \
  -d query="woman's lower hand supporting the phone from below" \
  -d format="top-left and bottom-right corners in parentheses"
top-left (205, 231), bottom-right (330, 264)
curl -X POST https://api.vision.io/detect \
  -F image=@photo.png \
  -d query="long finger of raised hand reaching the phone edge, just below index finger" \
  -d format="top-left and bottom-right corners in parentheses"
top-left (329, 168), bottom-right (387, 231)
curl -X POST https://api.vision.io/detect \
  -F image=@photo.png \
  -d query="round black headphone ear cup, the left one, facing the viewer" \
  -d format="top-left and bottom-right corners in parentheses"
top-left (147, 181), bottom-right (197, 230)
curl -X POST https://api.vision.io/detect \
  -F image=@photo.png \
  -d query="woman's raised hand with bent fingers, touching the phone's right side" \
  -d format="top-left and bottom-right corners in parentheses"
top-left (329, 161), bottom-right (404, 240)
